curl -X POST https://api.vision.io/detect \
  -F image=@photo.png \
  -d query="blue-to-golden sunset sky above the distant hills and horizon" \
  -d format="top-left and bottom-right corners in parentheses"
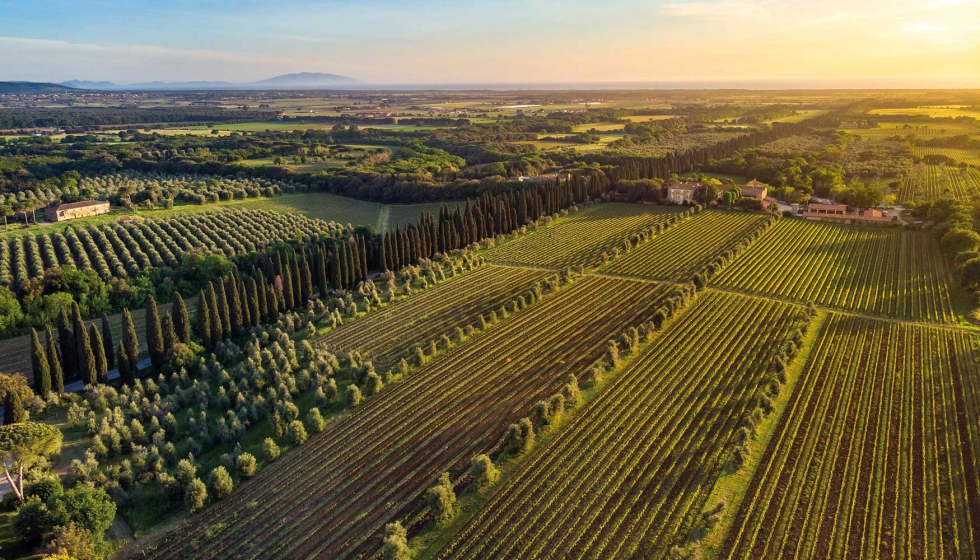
top-left (0, 0), bottom-right (980, 87)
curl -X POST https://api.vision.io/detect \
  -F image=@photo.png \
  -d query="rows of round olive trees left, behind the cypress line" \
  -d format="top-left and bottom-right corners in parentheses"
top-left (0, 210), bottom-right (344, 288)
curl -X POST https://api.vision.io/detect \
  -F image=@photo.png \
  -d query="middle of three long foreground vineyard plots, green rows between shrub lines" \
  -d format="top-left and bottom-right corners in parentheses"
top-left (438, 292), bottom-right (806, 559)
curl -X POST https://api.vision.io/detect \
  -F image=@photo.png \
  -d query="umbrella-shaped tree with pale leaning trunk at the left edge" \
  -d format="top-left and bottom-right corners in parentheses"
top-left (0, 424), bottom-right (61, 503)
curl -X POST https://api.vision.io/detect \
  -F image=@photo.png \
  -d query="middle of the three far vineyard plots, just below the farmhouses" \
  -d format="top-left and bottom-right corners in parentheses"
top-left (603, 211), bottom-right (768, 281)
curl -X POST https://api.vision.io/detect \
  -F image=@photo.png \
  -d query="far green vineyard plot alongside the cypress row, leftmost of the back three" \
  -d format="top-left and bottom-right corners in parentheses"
top-left (487, 204), bottom-right (687, 268)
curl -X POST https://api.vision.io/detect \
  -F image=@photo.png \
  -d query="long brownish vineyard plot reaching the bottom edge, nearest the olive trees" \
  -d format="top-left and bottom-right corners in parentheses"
top-left (144, 277), bottom-right (673, 559)
